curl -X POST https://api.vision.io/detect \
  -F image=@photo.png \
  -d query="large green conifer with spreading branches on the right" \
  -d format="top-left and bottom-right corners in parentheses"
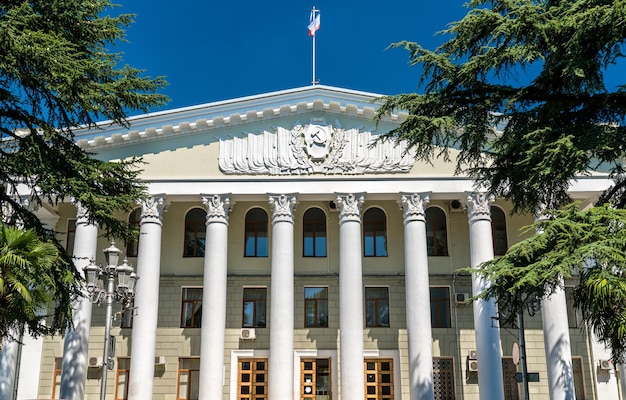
top-left (378, 0), bottom-right (626, 359)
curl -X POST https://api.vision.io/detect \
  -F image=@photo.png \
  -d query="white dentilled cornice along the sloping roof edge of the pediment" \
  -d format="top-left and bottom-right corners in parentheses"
top-left (75, 86), bottom-right (408, 151)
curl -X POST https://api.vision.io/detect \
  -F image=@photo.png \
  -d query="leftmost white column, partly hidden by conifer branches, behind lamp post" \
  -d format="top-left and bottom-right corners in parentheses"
top-left (61, 204), bottom-right (98, 400)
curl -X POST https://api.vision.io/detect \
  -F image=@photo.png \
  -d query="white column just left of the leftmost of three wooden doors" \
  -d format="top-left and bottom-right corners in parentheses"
top-left (199, 194), bottom-right (234, 400)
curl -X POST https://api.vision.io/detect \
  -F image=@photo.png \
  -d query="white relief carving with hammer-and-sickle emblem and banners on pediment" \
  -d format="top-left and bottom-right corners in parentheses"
top-left (219, 121), bottom-right (415, 175)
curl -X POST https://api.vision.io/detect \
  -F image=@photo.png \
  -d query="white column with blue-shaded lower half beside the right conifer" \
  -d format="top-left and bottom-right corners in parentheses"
top-left (467, 193), bottom-right (504, 400)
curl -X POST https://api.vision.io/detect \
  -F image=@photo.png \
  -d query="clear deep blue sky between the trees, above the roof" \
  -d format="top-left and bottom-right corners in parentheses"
top-left (115, 0), bottom-right (466, 113)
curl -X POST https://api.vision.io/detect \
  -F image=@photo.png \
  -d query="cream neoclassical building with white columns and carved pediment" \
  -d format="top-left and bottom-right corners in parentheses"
top-left (0, 85), bottom-right (620, 400)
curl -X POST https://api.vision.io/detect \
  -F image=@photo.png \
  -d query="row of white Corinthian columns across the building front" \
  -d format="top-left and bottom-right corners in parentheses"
top-left (56, 193), bottom-right (572, 400)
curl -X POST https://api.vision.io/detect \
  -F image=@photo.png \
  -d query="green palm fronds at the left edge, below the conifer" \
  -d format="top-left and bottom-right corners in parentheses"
top-left (0, 223), bottom-right (68, 339)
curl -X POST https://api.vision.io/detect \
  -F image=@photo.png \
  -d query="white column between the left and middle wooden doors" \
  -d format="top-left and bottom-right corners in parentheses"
top-left (268, 194), bottom-right (297, 400)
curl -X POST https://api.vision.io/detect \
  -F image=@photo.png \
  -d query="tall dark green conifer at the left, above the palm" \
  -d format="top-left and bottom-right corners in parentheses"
top-left (0, 0), bottom-right (167, 340)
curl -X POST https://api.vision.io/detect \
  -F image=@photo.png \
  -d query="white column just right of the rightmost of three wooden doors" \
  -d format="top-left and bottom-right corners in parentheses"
top-left (400, 193), bottom-right (435, 400)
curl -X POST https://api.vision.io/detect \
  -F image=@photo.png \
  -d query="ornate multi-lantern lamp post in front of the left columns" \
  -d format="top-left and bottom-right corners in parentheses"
top-left (84, 242), bottom-right (139, 400)
